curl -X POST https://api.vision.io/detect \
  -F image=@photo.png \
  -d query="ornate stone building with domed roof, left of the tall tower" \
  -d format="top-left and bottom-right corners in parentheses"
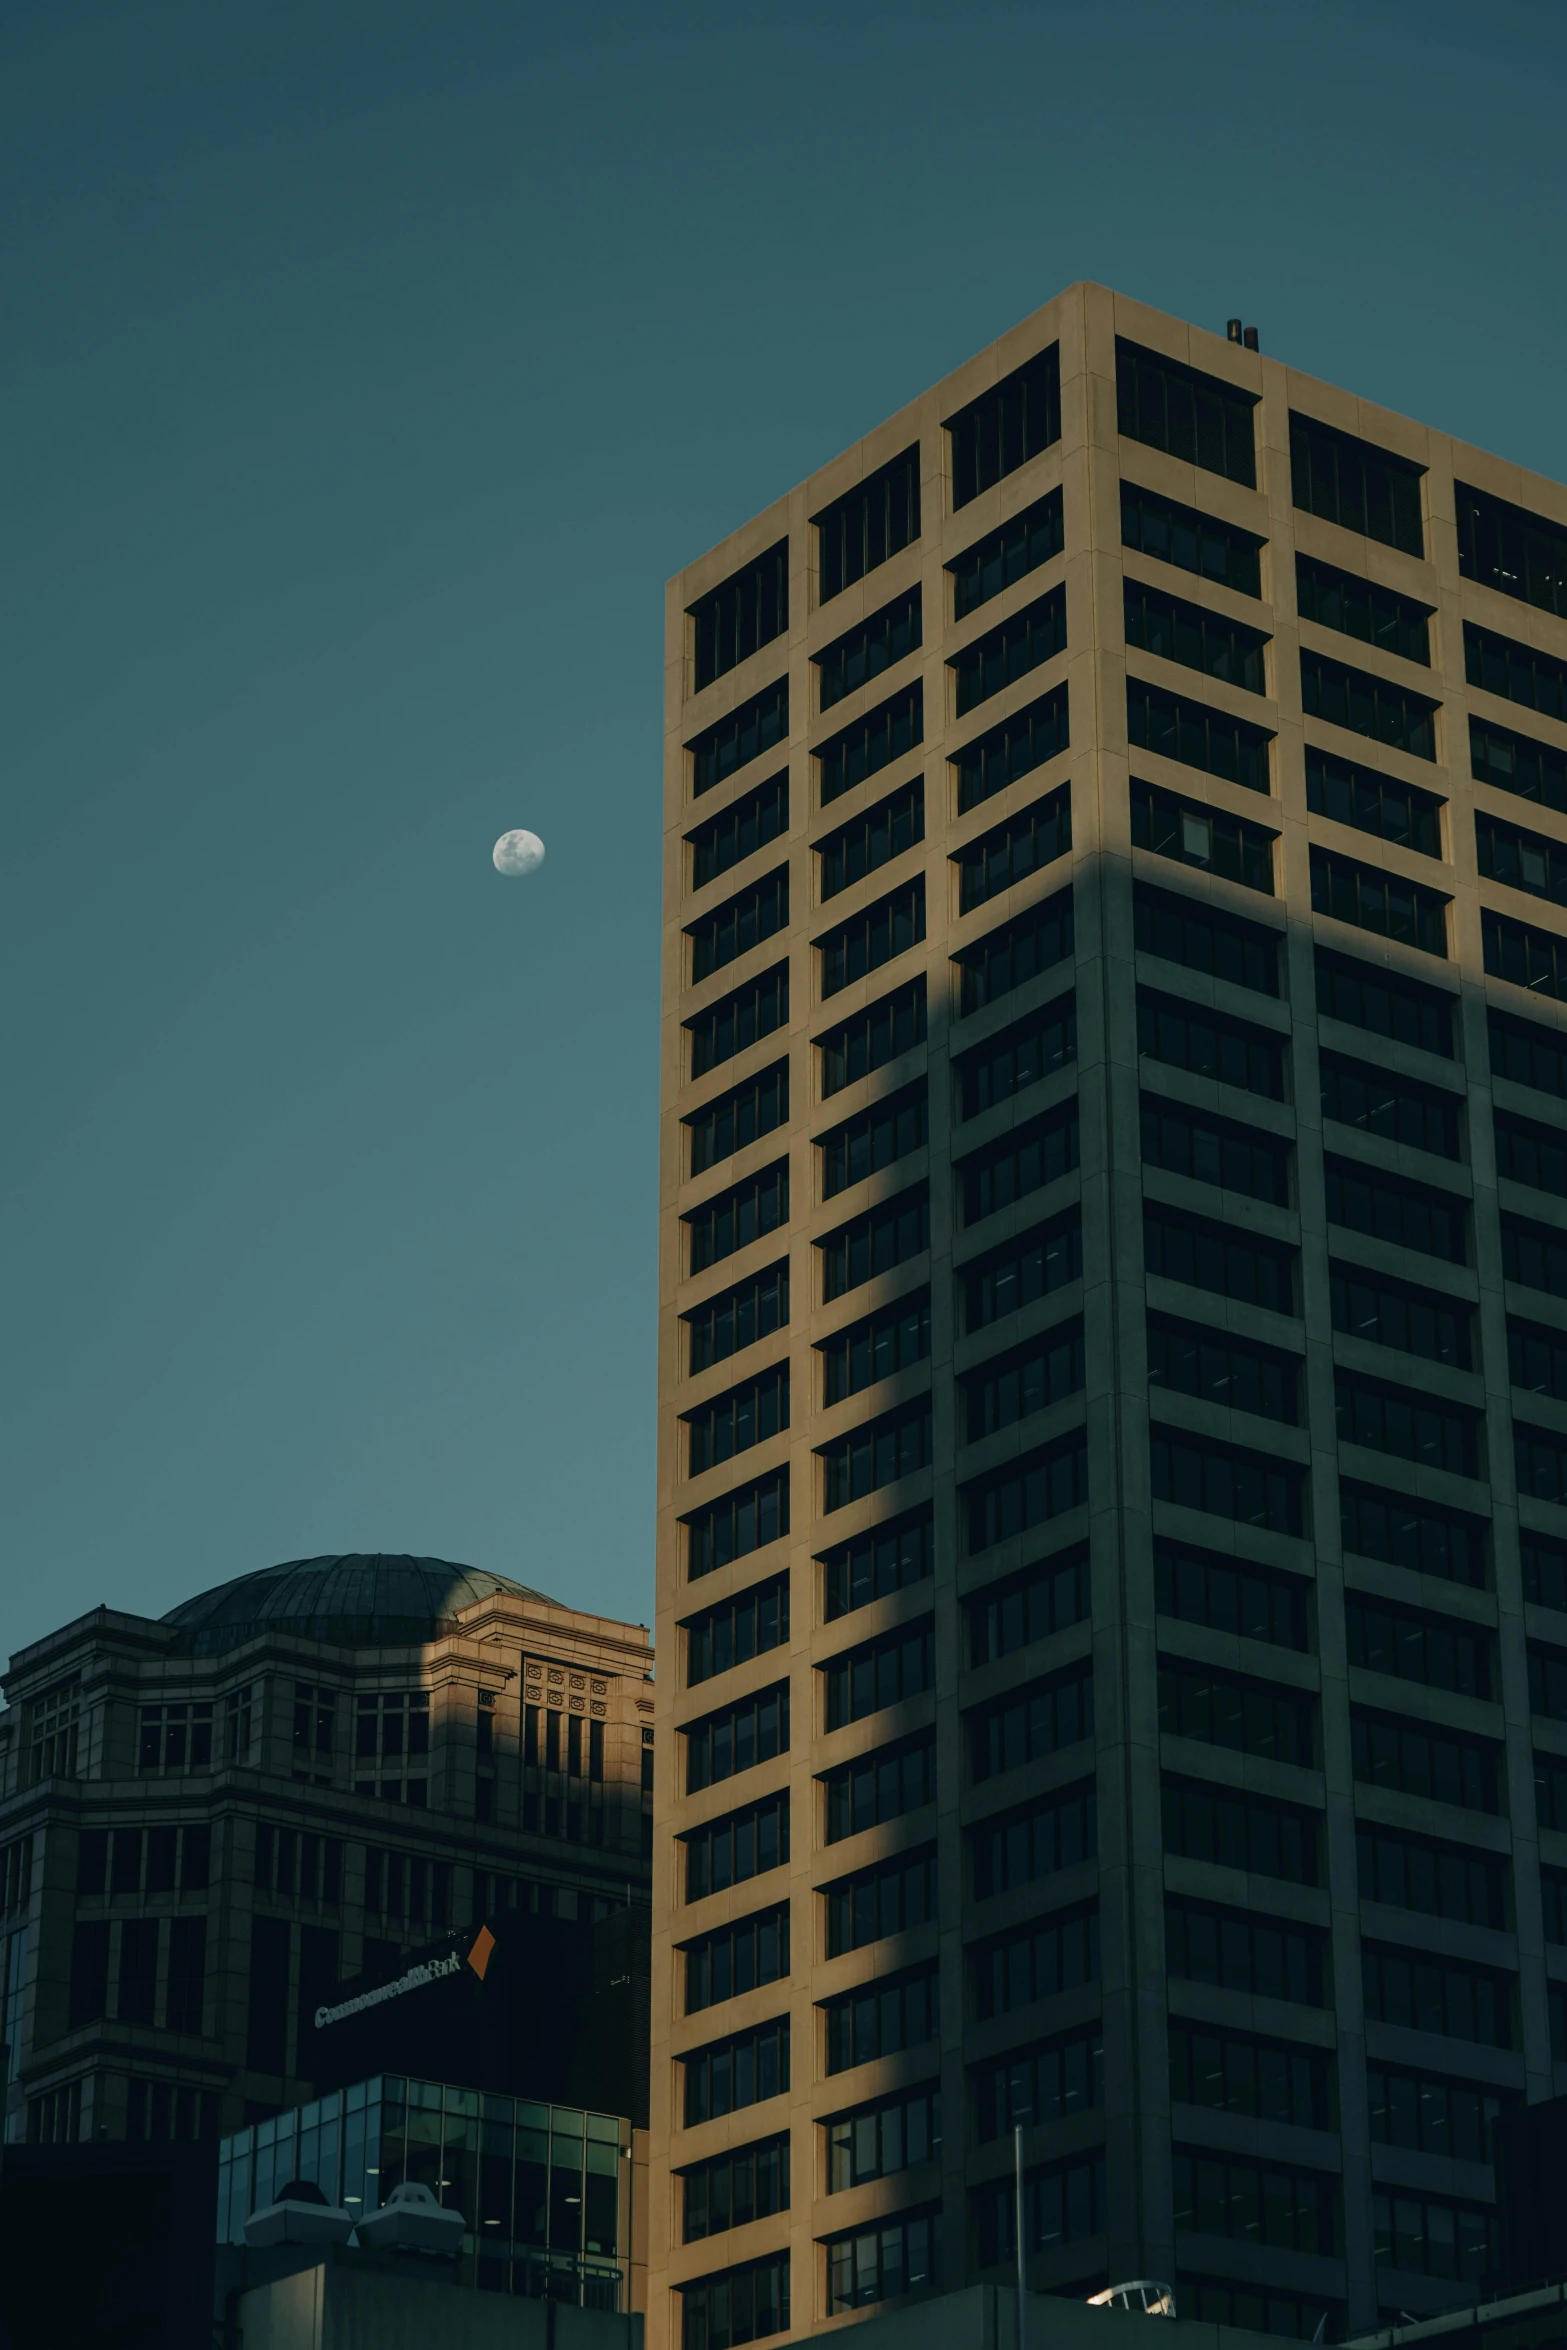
top-left (0, 1553), bottom-right (653, 2143)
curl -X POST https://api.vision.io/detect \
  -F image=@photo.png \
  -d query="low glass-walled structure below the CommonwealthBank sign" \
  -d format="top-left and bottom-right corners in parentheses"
top-left (218, 2073), bottom-right (632, 2310)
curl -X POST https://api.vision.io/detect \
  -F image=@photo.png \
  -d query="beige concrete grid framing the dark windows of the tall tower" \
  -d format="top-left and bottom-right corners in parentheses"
top-left (648, 284), bottom-right (1567, 2350)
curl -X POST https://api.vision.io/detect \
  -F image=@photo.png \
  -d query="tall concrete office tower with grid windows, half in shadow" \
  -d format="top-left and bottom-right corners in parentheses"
top-left (651, 284), bottom-right (1567, 2350)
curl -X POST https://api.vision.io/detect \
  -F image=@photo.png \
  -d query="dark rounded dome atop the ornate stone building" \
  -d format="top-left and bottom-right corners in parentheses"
top-left (162, 1551), bottom-right (559, 1657)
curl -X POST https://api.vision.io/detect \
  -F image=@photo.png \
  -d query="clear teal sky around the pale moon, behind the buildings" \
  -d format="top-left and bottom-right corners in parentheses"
top-left (0, 0), bottom-right (1567, 1654)
